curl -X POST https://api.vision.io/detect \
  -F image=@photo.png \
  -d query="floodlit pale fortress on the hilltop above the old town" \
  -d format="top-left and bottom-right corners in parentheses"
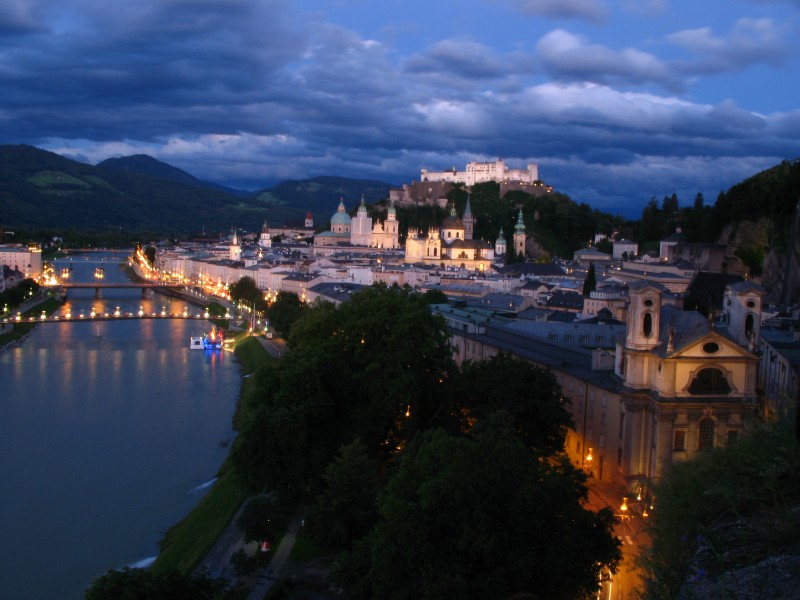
top-left (389, 158), bottom-right (553, 208)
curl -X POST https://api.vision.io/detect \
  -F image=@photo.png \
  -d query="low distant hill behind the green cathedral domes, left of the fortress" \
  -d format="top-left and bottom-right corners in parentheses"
top-left (255, 176), bottom-right (395, 222)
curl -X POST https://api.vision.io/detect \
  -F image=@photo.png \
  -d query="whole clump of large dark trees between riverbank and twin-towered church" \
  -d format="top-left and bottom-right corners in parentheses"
top-left (232, 285), bottom-right (619, 598)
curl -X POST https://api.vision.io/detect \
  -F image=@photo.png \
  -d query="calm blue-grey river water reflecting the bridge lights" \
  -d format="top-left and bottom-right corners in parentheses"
top-left (0, 253), bottom-right (240, 600)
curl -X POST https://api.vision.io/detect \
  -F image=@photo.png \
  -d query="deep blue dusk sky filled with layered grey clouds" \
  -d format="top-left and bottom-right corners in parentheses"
top-left (0, 0), bottom-right (800, 217)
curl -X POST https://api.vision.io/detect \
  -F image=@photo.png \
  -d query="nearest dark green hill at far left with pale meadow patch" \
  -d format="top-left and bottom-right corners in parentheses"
top-left (0, 146), bottom-right (274, 235)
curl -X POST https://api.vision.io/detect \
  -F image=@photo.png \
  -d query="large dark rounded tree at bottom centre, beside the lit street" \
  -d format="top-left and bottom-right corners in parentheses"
top-left (333, 420), bottom-right (620, 600)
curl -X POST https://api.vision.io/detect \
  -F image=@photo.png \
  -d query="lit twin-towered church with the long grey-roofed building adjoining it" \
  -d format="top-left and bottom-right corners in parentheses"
top-left (438, 281), bottom-right (763, 491)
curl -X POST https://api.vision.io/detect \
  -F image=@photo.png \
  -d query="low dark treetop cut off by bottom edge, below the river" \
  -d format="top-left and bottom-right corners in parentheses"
top-left (84, 567), bottom-right (231, 600)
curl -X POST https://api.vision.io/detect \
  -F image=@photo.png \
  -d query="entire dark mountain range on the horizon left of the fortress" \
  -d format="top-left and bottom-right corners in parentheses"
top-left (0, 145), bottom-right (398, 235)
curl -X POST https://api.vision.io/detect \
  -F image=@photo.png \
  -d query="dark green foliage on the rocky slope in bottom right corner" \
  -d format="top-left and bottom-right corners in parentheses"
top-left (643, 420), bottom-right (800, 600)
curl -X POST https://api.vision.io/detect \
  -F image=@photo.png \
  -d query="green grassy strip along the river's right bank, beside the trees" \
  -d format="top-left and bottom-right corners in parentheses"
top-left (152, 337), bottom-right (272, 573)
